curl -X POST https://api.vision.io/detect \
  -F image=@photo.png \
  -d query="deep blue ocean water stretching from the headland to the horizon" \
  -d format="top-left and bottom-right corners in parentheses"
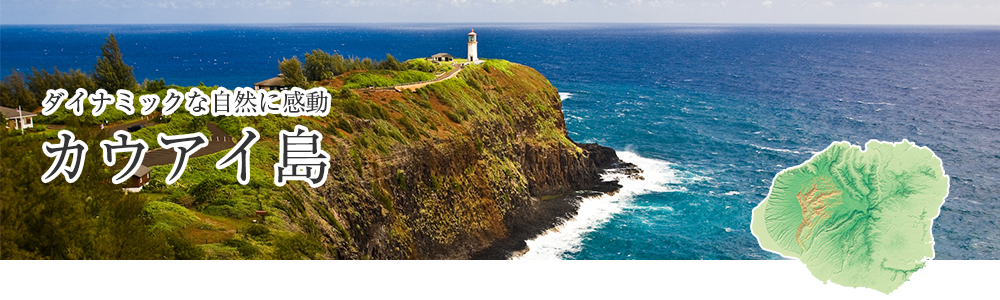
top-left (0, 24), bottom-right (1000, 259)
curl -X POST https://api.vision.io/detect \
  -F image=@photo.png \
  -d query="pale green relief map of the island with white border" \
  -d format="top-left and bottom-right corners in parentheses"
top-left (750, 140), bottom-right (949, 294)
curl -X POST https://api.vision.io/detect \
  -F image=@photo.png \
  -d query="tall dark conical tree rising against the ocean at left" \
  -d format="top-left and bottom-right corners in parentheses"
top-left (94, 33), bottom-right (139, 93)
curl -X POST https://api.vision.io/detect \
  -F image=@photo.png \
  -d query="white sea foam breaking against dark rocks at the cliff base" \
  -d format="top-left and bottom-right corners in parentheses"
top-left (514, 151), bottom-right (706, 259)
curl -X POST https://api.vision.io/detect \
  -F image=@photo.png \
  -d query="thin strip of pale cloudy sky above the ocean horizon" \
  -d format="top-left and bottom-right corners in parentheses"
top-left (0, 0), bottom-right (1000, 25)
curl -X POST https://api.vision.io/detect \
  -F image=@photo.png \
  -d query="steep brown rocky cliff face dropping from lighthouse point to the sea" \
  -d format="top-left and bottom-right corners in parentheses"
top-left (279, 61), bottom-right (618, 259)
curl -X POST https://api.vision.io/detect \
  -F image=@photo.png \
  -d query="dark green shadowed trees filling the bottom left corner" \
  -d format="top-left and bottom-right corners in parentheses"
top-left (0, 128), bottom-right (179, 259)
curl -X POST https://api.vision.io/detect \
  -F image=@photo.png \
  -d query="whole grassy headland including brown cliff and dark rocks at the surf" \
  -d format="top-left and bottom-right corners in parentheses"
top-left (3, 60), bottom-right (617, 259)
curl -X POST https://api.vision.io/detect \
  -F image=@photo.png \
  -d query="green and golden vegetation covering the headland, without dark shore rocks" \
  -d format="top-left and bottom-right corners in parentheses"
top-left (0, 51), bottom-right (577, 259)
